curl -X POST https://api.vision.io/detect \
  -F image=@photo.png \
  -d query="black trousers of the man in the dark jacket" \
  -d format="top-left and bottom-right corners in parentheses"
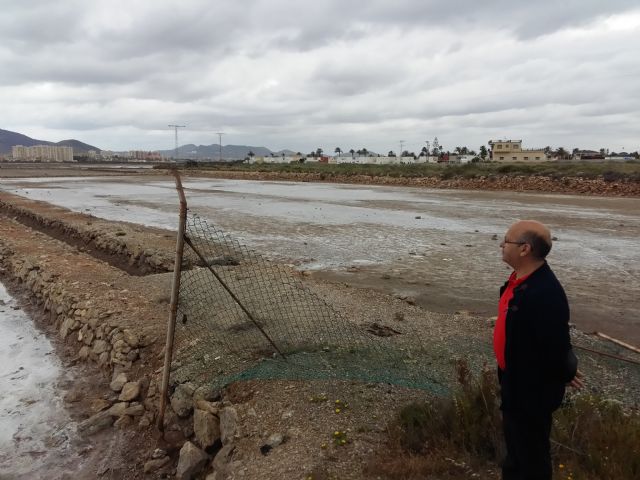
top-left (502, 411), bottom-right (552, 480)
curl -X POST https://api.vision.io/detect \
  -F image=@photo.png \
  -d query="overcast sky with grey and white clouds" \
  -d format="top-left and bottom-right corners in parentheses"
top-left (0, 0), bottom-right (640, 152)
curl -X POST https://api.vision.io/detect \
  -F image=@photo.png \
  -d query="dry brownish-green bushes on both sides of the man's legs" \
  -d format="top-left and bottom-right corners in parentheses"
top-left (368, 362), bottom-right (640, 480)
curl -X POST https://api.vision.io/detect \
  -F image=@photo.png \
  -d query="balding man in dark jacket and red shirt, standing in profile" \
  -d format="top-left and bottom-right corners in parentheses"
top-left (493, 220), bottom-right (582, 480)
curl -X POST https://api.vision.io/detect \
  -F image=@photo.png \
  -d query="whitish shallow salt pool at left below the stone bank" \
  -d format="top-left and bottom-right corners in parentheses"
top-left (0, 283), bottom-right (75, 480)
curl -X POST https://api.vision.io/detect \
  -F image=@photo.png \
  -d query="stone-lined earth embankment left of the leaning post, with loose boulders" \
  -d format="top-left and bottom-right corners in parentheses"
top-left (0, 197), bottom-right (245, 479)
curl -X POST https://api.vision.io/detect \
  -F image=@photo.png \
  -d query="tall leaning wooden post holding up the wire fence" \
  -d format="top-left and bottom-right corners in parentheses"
top-left (157, 170), bottom-right (187, 431)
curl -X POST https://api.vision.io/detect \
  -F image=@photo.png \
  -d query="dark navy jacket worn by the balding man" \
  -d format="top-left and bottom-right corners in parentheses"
top-left (499, 262), bottom-right (577, 414)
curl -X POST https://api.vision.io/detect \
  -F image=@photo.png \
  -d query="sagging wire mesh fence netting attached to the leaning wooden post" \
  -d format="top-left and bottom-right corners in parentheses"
top-left (171, 214), bottom-right (487, 393)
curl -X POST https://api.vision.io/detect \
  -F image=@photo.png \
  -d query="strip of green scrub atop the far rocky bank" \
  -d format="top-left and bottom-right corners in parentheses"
top-left (159, 160), bottom-right (640, 181)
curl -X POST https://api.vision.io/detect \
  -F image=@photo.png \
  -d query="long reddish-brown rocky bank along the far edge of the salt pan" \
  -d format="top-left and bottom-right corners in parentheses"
top-left (185, 170), bottom-right (640, 197)
